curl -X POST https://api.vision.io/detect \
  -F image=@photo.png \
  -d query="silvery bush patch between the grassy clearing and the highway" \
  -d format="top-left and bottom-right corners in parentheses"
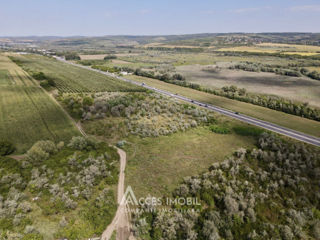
top-left (63, 93), bottom-right (213, 137)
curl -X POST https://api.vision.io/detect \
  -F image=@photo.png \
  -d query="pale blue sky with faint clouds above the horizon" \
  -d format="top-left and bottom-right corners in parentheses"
top-left (0, 0), bottom-right (320, 36)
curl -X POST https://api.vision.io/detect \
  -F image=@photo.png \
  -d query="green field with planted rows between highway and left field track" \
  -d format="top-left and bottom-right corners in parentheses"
top-left (9, 55), bottom-right (142, 93)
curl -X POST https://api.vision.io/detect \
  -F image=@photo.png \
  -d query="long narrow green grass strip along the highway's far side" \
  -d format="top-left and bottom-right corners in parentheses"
top-left (128, 76), bottom-right (320, 137)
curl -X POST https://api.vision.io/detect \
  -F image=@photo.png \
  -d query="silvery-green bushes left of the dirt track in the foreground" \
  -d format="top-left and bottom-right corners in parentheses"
top-left (0, 138), bottom-right (119, 239)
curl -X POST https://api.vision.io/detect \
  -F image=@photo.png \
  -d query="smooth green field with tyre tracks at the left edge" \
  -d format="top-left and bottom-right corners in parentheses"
top-left (0, 55), bottom-right (79, 153)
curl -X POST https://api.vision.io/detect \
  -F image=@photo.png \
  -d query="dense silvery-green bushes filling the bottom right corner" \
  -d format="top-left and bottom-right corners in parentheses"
top-left (133, 133), bottom-right (320, 240)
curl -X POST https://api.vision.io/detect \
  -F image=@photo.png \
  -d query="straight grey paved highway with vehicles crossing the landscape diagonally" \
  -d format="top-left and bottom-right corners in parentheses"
top-left (55, 57), bottom-right (320, 147)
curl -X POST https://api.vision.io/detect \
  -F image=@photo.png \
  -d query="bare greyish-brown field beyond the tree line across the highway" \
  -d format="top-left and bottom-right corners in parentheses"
top-left (176, 64), bottom-right (320, 107)
